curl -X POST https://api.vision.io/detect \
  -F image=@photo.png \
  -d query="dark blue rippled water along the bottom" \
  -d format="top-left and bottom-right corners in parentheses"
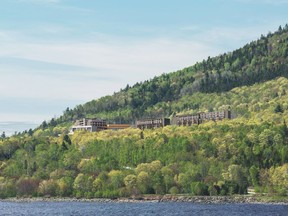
top-left (0, 202), bottom-right (288, 216)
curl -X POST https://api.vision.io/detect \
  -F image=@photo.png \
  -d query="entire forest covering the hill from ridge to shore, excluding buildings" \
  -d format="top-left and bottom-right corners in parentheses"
top-left (0, 25), bottom-right (288, 198)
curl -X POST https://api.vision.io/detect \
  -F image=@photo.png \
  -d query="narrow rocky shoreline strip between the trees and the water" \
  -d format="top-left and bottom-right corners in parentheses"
top-left (0, 195), bottom-right (288, 205)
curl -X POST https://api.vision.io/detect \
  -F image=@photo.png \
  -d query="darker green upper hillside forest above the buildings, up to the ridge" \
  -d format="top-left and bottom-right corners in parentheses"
top-left (44, 25), bottom-right (288, 126)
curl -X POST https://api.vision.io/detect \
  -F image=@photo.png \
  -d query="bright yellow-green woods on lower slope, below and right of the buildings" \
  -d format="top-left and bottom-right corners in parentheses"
top-left (0, 77), bottom-right (288, 198)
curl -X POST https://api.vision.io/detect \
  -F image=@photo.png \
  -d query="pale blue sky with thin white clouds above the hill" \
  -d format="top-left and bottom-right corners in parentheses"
top-left (0, 0), bottom-right (288, 134)
